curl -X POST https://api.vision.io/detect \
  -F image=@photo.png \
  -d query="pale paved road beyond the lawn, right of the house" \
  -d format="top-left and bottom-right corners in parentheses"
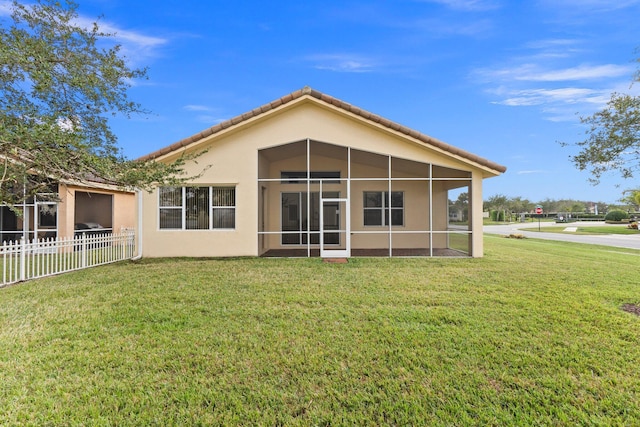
top-left (484, 221), bottom-right (640, 249)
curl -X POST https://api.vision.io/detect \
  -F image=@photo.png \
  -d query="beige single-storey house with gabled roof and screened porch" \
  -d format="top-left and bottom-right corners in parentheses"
top-left (139, 87), bottom-right (506, 257)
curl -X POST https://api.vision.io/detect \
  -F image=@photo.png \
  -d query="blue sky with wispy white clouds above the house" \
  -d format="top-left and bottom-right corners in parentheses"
top-left (10, 0), bottom-right (640, 202)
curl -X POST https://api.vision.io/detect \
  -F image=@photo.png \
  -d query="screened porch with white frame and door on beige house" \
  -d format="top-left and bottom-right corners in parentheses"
top-left (258, 140), bottom-right (473, 257)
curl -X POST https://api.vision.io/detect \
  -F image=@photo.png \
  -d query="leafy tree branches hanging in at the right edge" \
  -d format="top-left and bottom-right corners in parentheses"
top-left (563, 52), bottom-right (640, 184)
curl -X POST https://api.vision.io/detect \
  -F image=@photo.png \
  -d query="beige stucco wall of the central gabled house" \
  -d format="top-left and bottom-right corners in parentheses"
top-left (142, 99), bottom-right (498, 257)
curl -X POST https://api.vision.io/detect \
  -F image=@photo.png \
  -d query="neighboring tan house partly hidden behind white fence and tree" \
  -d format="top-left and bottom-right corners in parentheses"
top-left (0, 182), bottom-right (136, 242)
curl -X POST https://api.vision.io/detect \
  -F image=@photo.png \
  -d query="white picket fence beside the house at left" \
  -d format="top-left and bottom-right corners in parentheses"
top-left (0, 230), bottom-right (135, 287)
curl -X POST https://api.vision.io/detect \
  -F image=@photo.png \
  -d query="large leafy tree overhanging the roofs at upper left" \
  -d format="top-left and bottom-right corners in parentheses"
top-left (0, 0), bottom-right (190, 205)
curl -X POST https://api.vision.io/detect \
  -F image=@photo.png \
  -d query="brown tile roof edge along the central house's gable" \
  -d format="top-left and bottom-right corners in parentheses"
top-left (139, 86), bottom-right (507, 173)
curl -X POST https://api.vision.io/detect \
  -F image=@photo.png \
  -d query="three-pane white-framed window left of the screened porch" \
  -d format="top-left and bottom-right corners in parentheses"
top-left (158, 187), bottom-right (236, 230)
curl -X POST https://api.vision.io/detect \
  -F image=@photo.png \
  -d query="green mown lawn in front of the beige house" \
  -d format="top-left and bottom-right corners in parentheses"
top-left (0, 236), bottom-right (640, 426)
